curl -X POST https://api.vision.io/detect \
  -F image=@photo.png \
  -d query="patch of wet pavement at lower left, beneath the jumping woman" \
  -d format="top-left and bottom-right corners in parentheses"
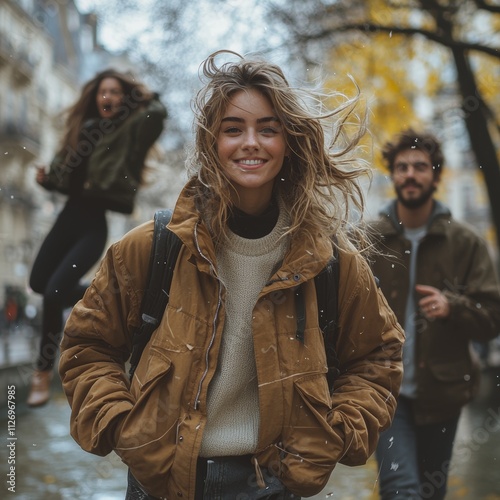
top-left (0, 392), bottom-right (126, 500)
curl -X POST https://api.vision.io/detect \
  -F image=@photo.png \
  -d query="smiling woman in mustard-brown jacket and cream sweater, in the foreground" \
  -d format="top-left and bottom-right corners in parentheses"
top-left (59, 51), bottom-right (403, 500)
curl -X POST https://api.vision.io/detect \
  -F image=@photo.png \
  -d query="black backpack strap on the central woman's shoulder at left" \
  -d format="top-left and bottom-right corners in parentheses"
top-left (129, 209), bottom-right (182, 378)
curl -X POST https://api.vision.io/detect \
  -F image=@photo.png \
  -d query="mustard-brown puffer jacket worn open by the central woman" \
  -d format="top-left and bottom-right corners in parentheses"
top-left (60, 184), bottom-right (403, 499)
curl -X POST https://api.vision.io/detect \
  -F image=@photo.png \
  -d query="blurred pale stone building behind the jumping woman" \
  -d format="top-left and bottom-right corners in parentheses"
top-left (0, 0), bottom-right (182, 318)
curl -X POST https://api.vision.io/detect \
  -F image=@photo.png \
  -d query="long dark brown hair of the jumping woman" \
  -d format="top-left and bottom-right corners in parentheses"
top-left (59, 68), bottom-right (152, 154)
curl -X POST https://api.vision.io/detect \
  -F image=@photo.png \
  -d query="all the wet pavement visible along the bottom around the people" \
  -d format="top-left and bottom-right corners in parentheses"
top-left (0, 330), bottom-right (500, 500)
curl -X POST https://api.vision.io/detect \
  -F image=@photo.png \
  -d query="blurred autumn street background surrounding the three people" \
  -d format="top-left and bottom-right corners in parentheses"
top-left (0, 0), bottom-right (500, 500)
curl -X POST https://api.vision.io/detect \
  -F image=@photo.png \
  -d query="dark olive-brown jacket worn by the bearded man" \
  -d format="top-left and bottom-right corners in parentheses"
top-left (371, 201), bottom-right (500, 423)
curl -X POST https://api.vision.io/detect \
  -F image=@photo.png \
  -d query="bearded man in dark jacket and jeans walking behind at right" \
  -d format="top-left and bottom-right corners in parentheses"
top-left (371, 129), bottom-right (500, 500)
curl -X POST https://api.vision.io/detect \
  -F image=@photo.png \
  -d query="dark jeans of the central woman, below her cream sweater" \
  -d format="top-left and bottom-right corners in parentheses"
top-left (125, 455), bottom-right (300, 500)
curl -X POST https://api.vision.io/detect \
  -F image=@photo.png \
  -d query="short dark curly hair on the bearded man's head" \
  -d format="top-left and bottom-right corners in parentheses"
top-left (382, 128), bottom-right (444, 179)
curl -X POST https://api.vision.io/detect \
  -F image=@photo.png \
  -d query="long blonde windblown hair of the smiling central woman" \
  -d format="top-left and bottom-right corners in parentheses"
top-left (187, 51), bottom-right (368, 247)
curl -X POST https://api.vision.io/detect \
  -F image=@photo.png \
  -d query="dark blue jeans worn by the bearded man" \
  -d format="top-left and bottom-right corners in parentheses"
top-left (376, 396), bottom-right (460, 500)
